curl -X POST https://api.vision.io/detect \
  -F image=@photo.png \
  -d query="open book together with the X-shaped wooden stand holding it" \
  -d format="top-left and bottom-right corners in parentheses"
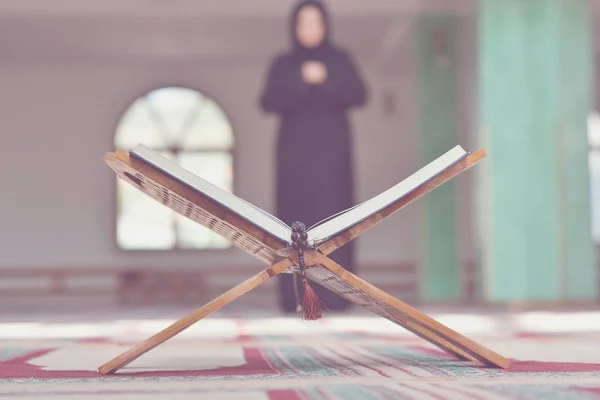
top-left (99, 145), bottom-right (509, 374)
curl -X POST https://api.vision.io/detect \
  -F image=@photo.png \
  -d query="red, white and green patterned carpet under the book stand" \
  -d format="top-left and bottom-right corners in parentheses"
top-left (0, 311), bottom-right (600, 400)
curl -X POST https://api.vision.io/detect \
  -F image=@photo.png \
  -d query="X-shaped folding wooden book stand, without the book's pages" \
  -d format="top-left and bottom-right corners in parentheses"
top-left (98, 150), bottom-right (510, 374)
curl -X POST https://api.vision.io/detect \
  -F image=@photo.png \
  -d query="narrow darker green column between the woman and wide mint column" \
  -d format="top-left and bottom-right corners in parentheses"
top-left (415, 15), bottom-right (462, 301)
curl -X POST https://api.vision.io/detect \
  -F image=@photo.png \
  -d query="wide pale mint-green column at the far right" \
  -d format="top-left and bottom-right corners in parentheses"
top-left (477, 0), bottom-right (597, 302)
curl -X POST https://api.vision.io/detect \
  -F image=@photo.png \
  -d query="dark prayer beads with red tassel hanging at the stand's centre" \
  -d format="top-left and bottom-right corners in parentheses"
top-left (292, 222), bottom-right (322, 321)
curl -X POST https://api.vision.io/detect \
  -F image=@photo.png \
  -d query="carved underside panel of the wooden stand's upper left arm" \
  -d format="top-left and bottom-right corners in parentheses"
top-left (107, 155), bottom-right (280, 264)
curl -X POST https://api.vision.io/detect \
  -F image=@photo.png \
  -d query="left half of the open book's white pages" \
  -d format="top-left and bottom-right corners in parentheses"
top-left (130, 145), bottom-right (292, 243)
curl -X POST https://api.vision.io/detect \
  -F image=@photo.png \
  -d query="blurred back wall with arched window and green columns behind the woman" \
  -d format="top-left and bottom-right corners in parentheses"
top-left (0, 0), bottom-right (600, 312)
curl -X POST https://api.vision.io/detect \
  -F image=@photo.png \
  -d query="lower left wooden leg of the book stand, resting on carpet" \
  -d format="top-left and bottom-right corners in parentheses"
top-left (98, 259), bottom-right (292, 375)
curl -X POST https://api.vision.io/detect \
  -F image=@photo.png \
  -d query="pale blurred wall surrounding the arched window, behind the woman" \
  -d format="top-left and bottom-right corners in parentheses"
top-left (0, 57), bottom-right (442, 268)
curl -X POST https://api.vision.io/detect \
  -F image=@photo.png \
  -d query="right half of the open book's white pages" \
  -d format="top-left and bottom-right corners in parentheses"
top-left (308, 146), bottom-right (468, 243)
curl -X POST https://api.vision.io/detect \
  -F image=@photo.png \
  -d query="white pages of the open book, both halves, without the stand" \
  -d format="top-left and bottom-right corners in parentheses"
top-left (124, 145), bottom-right (469, 247)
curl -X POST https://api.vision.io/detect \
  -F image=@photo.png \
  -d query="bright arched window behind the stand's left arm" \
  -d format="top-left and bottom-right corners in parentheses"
top-left (115, 87), bottom-right (234, 250)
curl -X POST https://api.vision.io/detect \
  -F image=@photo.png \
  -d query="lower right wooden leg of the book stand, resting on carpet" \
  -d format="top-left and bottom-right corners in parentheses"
top-left (305, 251), bottom-right (510, 368)
